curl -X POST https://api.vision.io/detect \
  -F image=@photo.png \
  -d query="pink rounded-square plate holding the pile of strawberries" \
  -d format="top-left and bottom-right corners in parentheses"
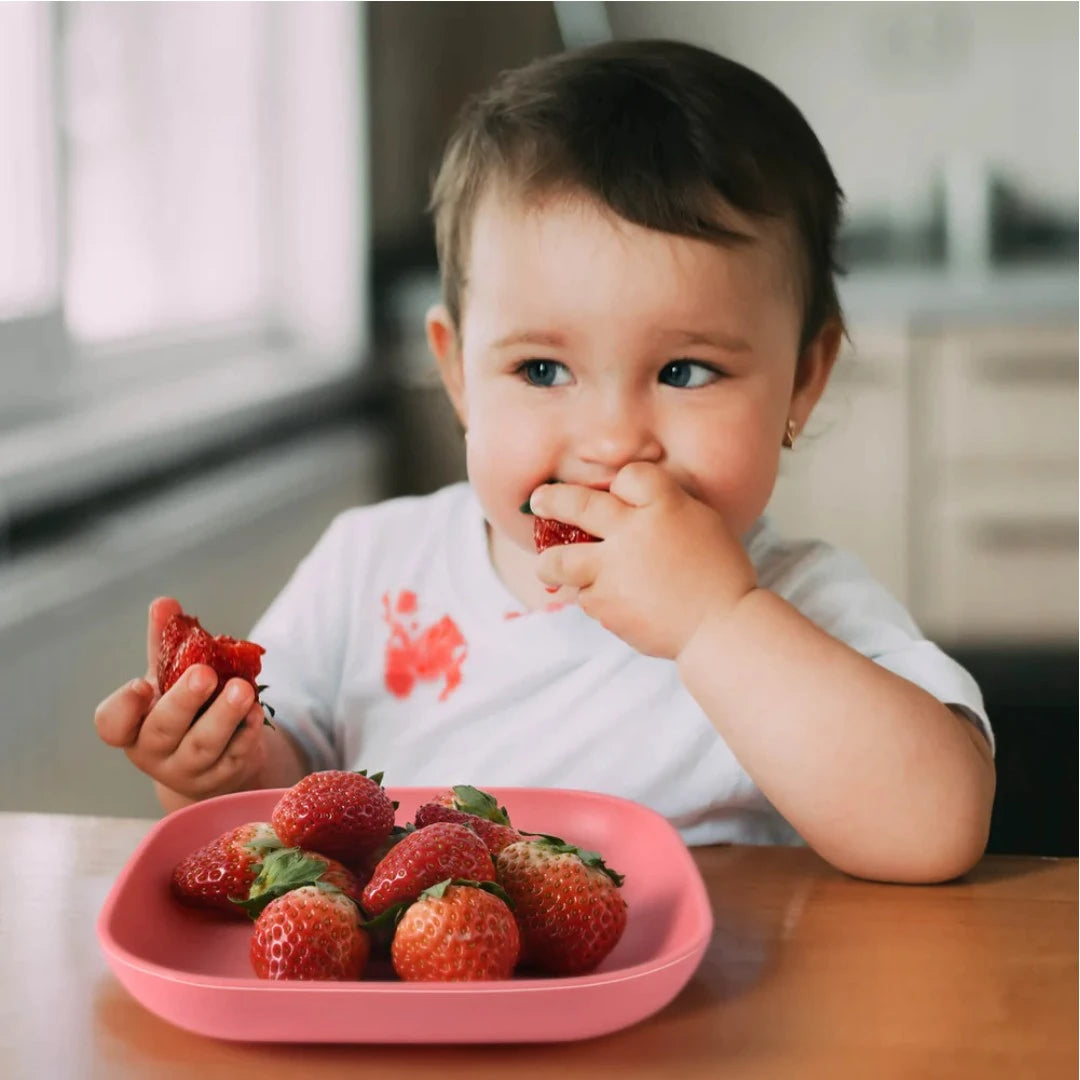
top-left (97, 787), bottom-right (713, 1043)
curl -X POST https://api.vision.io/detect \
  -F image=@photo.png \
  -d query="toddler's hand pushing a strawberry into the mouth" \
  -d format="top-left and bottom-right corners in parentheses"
top-left (529, 462), bottom-right (757, 660)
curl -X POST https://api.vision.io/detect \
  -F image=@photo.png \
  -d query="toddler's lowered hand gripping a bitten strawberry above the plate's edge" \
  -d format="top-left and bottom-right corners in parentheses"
top-left (94, 597), bottom-right (267, 799)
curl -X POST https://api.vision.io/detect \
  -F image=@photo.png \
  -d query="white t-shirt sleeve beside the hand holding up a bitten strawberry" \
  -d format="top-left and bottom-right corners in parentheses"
top-left (251, 512), bottom-right (354, 770)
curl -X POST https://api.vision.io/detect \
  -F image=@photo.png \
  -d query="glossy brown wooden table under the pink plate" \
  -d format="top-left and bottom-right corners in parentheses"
top-left (0, 813), bottom-right (1078, 1080)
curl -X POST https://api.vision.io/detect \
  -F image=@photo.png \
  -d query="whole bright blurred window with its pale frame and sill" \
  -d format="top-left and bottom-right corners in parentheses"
top-left (0, 2), bottom-right (367, 513)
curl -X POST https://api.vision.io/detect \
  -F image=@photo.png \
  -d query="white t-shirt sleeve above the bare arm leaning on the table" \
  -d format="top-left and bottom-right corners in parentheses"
top-left (751, 527), bottom-right (995, 751)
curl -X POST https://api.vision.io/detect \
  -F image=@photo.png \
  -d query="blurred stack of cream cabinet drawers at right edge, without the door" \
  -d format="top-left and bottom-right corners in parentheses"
top-left (912, 324), bottom-right (1078, 643)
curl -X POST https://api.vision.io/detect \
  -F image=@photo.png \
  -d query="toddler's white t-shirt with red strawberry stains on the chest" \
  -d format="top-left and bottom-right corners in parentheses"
top-left (252, 484), bottom-right (993, 843)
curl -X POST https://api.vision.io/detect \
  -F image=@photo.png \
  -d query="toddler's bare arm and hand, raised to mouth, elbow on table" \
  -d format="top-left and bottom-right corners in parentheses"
top-left (531, 463), bottom-right (995, 882)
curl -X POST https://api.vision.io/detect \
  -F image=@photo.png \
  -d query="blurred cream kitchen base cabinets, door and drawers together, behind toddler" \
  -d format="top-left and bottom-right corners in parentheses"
top-left (769, 320), bottom-right (1078, 644)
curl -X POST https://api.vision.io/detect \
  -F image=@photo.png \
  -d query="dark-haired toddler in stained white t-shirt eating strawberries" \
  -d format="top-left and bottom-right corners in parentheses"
top-left (96, 41), bottom-right (995, 881)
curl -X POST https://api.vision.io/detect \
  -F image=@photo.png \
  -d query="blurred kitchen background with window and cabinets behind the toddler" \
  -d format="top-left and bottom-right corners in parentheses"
top-left (0, 2), bottom-right (1078, 853)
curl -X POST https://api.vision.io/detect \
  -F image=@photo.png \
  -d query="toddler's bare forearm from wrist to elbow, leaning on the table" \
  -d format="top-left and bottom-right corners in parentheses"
top-left (678, 590), bottom-right (995, 881)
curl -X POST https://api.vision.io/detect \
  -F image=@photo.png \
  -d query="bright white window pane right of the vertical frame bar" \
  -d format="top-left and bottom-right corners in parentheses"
top-left (60, 3), bottom-right (275, 342)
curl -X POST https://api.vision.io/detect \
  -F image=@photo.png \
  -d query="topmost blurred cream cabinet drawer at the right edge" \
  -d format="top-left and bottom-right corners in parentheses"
top-left (914, 326), bottom-right (1078, 465)
